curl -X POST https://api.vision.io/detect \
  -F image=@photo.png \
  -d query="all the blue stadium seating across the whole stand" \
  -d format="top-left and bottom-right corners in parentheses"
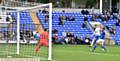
top-left (7, 11), bottom-right (120, 45)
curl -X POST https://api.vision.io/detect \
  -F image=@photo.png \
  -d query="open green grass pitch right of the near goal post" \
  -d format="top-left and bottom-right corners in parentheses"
top-left (53, 45), bottom-right (120, 61)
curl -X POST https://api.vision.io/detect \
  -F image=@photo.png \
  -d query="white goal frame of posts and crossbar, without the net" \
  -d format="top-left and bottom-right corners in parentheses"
top-left (0, 3), bottom-right (52, 60)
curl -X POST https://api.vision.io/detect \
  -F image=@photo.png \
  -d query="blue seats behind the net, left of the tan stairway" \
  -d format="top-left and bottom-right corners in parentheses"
top-left (9, 11), bottom-right (35, 31)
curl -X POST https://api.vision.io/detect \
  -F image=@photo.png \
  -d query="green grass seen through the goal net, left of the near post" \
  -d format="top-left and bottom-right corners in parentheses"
top-left (0, 44), bottom-right (48, 59)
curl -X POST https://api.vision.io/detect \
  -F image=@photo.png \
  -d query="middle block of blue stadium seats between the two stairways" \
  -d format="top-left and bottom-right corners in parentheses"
top-left (38, 12), bottom-right (92, 37)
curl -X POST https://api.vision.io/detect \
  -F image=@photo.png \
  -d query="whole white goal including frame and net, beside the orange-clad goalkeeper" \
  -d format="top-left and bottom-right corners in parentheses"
top-left (0, 3), bottom-right (52, 60)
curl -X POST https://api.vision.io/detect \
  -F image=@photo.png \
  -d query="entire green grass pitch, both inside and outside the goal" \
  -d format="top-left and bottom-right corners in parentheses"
top-left (0, 44), bottom-right (120, 61)
